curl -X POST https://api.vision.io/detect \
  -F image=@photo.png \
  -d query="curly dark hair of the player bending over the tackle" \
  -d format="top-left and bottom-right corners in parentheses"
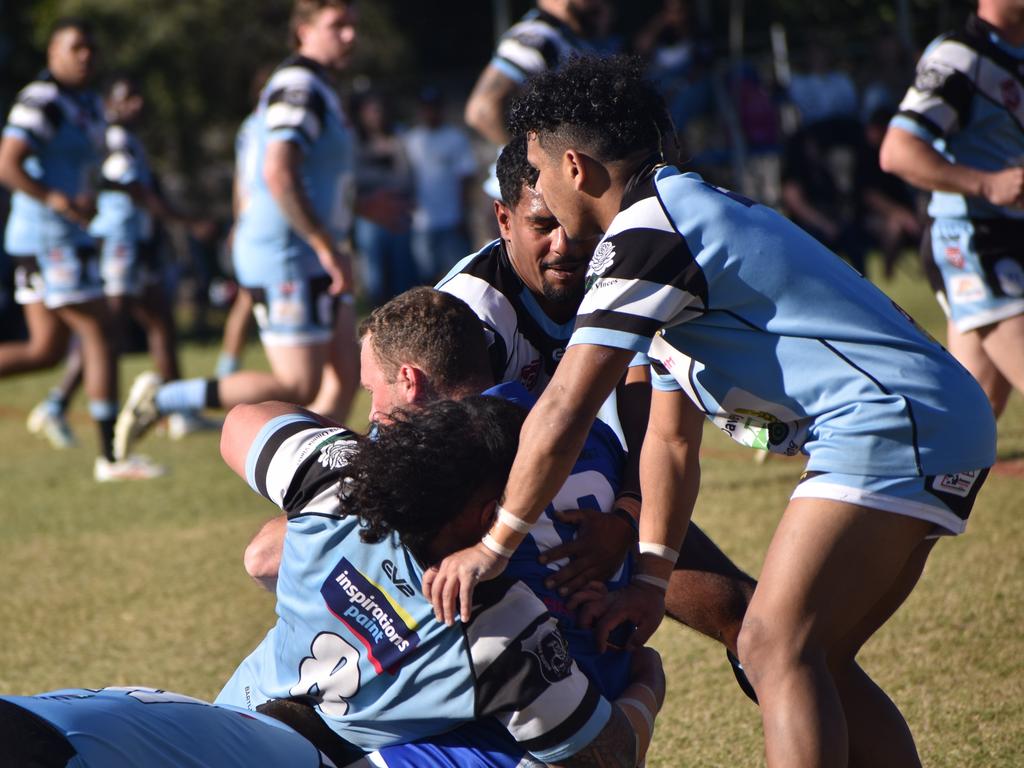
top-left (508, 56), bottom-right (673, 163)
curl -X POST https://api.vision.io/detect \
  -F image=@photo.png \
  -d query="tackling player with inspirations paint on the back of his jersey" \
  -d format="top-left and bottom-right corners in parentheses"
top-left (217, 352), bottom-right (664, 765)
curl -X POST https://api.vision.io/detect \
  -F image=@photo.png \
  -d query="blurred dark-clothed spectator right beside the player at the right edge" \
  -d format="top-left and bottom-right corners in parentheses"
top-left (855, 108), bottom-right (922, 279)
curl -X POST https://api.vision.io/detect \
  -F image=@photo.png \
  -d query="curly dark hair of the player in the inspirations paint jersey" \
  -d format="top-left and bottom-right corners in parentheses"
top-left (338, 395), bottom-right (526, 563)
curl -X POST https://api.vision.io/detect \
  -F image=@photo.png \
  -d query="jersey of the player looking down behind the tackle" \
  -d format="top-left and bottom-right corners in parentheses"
top-left (436, 240), bottom-right (572, 393)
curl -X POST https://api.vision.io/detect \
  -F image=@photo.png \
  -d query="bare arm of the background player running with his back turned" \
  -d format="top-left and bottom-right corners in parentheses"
top-left (263, 141), bottom-right (352, 294)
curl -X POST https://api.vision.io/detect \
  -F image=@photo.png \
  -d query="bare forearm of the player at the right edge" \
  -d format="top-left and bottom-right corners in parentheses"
top-left (879, 128), bottom-right (986, 197)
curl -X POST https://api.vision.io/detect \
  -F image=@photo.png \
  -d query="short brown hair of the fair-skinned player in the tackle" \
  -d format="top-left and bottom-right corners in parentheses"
top-left (359, 288), bottom-right (494, 397)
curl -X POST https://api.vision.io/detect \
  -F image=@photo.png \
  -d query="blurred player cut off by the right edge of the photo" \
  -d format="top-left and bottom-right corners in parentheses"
top-left (881, 0), bottom-right (1024, 417)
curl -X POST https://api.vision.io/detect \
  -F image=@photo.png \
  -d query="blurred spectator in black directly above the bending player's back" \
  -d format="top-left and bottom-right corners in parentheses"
top-left (782, 120), bottom-right (867, 273)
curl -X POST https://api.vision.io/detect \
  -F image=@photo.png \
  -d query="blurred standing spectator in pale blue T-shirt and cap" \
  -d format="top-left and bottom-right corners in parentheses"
top-left (404, 86), bottom-right (476, 283)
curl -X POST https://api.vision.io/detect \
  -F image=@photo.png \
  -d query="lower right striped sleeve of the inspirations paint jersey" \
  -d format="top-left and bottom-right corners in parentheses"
top-left (465, 578), bottom-right (611, 762)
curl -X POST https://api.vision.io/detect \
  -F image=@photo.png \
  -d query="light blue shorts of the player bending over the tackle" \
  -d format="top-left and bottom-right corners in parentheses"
top-left (791, 468), bottom-right (988, 537)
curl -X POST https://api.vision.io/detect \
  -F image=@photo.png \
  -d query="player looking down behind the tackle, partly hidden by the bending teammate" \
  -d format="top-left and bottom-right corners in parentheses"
top-left (437, 136), bottom-right (755, 694)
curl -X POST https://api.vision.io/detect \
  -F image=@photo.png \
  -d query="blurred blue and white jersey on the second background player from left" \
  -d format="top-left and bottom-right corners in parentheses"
top-left (89, 125), bottom-right (153, 243)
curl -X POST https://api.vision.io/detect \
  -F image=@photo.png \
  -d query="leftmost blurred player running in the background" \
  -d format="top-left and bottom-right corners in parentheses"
top-left (0, 18), bottom-right (152, 480)
